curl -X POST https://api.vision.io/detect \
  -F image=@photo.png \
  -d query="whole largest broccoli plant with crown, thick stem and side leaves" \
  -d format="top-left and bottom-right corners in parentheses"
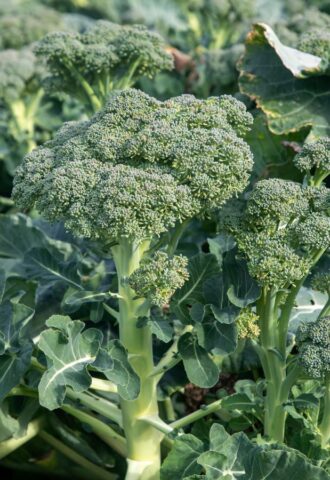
top-left (13, 88), bottom-right (252, 480)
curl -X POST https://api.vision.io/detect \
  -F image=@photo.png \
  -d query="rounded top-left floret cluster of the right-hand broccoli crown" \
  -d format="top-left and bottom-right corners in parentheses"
top-left (246, 178), bottom-right (309, 231)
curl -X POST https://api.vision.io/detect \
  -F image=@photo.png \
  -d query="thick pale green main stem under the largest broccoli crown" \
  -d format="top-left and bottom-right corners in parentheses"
top-left (112, 239), bottom-right (163, 480)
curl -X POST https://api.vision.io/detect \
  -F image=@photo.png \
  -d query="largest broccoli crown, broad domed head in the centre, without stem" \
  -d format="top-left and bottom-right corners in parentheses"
top-left (13, 89), bottom-right (253, 241)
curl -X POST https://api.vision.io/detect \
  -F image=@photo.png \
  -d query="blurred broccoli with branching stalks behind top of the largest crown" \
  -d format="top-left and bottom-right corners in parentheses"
top-left (35, 20), bottom-right (173, 112)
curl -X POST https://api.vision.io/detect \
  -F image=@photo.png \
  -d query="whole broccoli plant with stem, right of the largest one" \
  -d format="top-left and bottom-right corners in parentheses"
top-left (222, 138), bottom-right (330, 442)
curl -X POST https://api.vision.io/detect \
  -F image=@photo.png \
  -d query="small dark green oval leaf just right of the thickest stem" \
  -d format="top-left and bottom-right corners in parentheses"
top-left (178, 333), bottom-right (219, 388)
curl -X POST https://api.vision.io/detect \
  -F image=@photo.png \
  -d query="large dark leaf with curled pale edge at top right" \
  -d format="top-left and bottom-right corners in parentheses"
top-left (239, 23), bottom-right (330, 137)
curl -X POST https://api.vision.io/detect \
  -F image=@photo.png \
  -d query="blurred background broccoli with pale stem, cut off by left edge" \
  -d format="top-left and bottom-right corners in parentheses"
top-left (0, 48), bottom-right (43, 174)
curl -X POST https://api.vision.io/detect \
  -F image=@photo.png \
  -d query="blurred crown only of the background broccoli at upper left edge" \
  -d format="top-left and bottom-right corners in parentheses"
top-left (0, 49), bottom-right (38, 103)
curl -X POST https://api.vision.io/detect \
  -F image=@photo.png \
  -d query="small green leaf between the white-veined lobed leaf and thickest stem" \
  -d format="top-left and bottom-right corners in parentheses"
top-left (93, 340), bottom-right (140, 400)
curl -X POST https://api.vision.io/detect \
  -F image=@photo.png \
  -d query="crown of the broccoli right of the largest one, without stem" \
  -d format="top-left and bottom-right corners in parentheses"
top-left (220, 178), bottom-right (330, 288)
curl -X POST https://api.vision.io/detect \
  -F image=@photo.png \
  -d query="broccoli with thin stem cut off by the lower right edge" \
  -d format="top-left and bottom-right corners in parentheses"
top-left (296, 315), bottom-right (330, 448)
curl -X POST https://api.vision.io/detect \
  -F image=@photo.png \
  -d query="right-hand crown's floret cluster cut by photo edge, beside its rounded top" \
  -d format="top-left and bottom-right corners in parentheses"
top-left (292, 213), bottom-right (330, 250)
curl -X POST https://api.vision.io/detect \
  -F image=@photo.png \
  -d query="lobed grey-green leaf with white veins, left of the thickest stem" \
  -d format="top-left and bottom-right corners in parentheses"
top-left (38, 315), bottom-right (102, 410)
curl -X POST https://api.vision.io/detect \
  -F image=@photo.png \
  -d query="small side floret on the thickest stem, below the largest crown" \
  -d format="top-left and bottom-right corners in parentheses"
top-left (129, 252), bottom-right (189, 307)
